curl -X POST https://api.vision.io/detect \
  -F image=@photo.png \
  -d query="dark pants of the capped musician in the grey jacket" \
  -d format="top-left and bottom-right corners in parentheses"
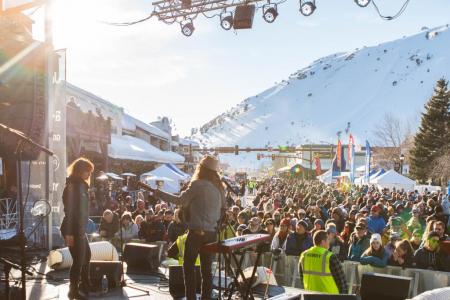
top-left (183, 230), bottom-right (216, 300)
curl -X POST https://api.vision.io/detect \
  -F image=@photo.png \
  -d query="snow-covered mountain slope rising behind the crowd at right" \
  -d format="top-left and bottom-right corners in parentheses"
top-left (193, 25), bottom-right (450, 147)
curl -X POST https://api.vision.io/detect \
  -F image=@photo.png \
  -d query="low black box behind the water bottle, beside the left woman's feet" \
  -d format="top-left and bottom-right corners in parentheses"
top-left (89, 260), bottom-right (122, 290)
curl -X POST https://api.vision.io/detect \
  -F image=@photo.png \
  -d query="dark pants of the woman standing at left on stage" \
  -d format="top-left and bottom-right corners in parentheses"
top-left (69, 235), bottom-right (91, 289)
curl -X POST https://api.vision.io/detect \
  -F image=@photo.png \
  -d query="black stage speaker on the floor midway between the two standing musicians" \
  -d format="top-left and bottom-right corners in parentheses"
top-left (123, 243), bottom-right (159, 271)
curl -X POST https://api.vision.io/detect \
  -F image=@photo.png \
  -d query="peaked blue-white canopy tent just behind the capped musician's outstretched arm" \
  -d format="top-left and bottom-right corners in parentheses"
top-left (140, 164), bottom-right (189, 193)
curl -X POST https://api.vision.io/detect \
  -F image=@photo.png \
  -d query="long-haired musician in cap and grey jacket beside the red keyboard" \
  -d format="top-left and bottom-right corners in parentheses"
top-left (155, 155), bottom-right (225, 300)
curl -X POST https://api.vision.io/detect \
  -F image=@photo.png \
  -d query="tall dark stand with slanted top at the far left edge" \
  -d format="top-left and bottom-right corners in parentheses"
top-left (0, 123), bottom-right (53, 300)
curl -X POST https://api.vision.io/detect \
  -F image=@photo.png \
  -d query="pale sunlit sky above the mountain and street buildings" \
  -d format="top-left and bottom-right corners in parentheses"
top-left (34, 0), bottom-right (450, 135)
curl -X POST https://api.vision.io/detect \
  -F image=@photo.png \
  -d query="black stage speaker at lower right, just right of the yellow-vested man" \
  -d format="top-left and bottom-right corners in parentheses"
top-left (361, 273), bottom-right (412, 300)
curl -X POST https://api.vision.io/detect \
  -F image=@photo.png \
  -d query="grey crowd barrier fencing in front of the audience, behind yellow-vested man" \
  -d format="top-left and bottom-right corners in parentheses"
top-left (232, 253), bottom-right (450, 297)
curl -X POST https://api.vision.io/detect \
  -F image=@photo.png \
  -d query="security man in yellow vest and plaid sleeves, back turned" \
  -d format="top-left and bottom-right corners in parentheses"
top-left (298, 230), bottom-right (348, 294)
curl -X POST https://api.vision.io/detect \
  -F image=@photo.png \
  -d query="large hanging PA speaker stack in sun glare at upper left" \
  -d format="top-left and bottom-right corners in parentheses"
top-left (0, 41), bottom-right (46, 160)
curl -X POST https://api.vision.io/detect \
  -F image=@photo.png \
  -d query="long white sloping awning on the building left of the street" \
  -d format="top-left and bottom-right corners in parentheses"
top-left (108, 134), bottom-right (184, 164)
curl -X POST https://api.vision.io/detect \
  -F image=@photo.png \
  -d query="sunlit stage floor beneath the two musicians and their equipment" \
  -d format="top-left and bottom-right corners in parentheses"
top-left (0, 262), bottom-right (301, 300)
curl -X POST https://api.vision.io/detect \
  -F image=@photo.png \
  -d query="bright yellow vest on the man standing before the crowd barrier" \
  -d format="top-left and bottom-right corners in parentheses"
top-left (299, 246), bottom-right (339, 294)
